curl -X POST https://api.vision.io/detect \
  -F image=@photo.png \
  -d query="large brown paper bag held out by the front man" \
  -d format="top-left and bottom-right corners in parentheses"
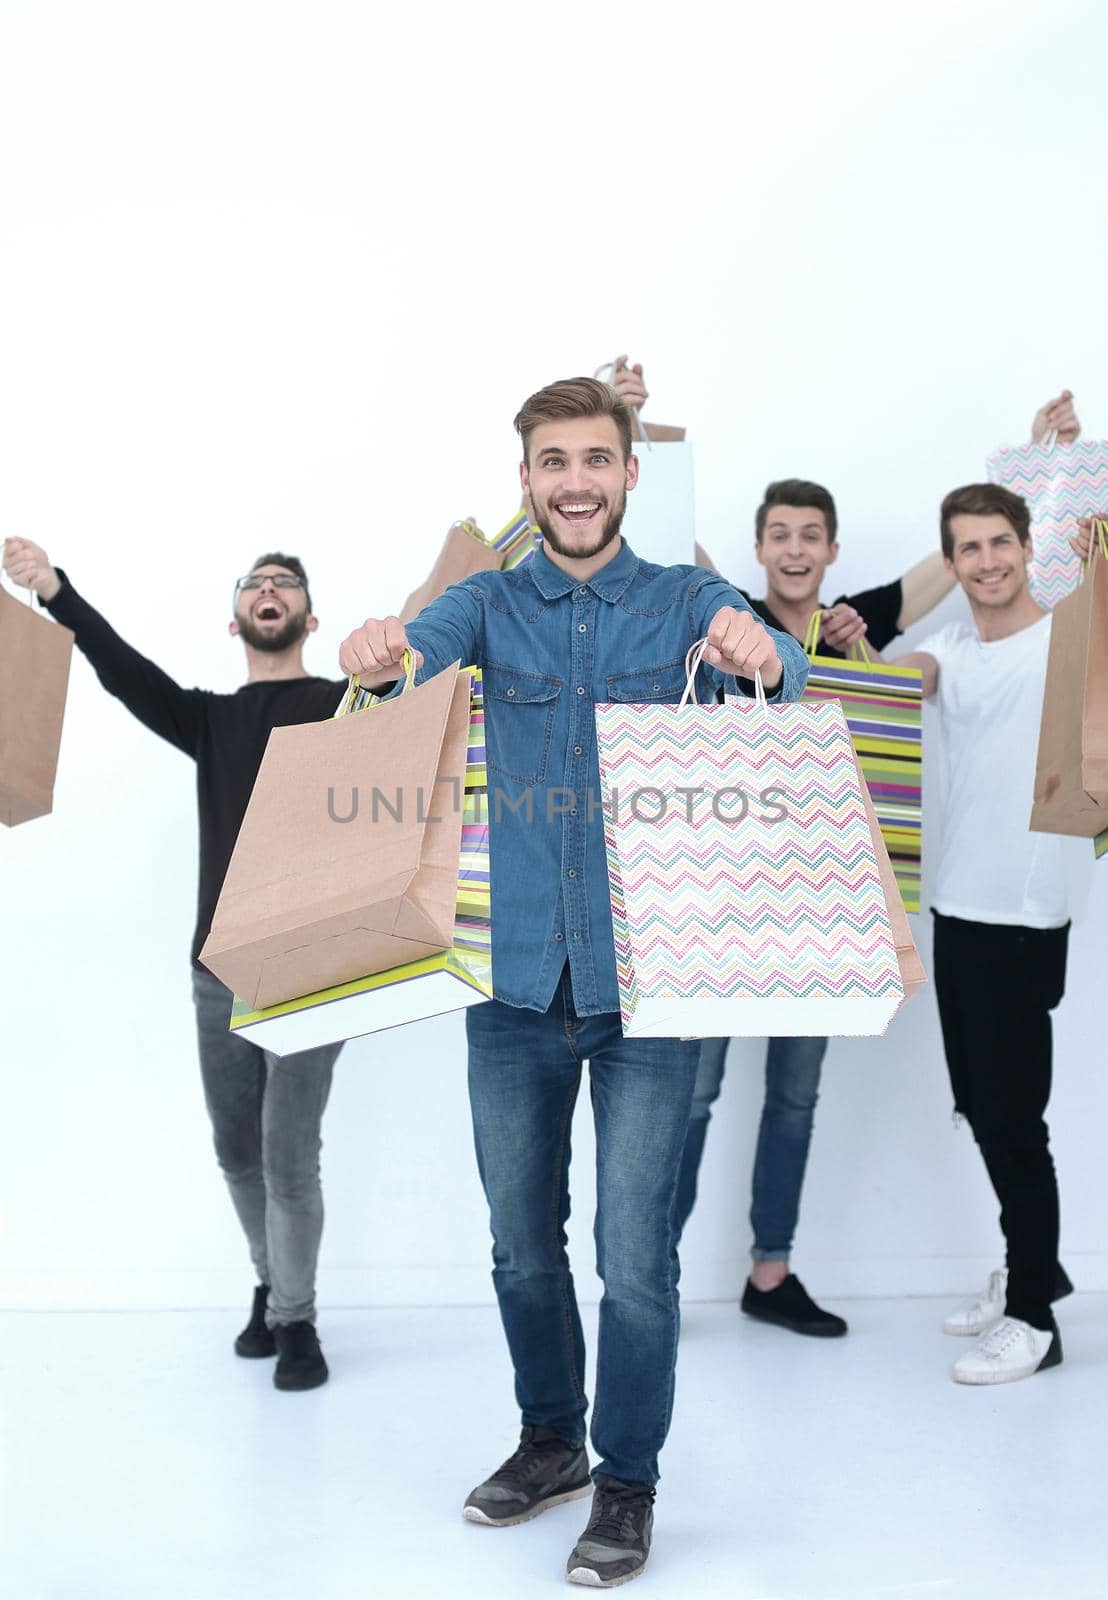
top-left (200, 664), bottom-right (469, 1010)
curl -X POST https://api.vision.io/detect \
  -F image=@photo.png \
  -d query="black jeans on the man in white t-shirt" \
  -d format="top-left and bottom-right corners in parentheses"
top-left (933, 912), bottom-right (1070, 1330)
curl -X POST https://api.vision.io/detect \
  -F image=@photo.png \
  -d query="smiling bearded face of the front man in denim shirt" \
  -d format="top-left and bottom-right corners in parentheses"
top-left (519, 416), bottom-right (639, 560)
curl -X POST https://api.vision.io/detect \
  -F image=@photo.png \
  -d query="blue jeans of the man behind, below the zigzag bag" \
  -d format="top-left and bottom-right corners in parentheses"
top-left (677, 1038), bottom-right (828, 1261)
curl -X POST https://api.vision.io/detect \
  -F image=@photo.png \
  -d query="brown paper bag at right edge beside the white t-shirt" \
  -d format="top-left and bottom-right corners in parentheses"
top-left (1031, 531), bottom-right (1108, 838)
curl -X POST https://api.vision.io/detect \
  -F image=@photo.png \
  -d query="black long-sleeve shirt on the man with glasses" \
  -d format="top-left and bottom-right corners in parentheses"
top-left (46, 571), bottom-right (346, 965)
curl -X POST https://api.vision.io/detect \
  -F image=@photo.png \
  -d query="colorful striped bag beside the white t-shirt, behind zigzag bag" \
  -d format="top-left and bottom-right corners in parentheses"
top-left (804, 611), bottom-right (924, 910)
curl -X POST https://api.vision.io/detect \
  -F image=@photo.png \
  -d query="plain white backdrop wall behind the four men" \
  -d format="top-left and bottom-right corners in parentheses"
top-left (0, 0), bottom-right (1108, 1306)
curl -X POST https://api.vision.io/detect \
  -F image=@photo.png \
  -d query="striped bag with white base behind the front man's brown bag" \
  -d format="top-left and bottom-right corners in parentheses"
top-left (231, 667), bottom-right (493, 1056)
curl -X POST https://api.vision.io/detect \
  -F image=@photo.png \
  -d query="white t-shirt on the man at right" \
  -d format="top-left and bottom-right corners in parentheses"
top-left (916, 616), bottom-right (1070, 928)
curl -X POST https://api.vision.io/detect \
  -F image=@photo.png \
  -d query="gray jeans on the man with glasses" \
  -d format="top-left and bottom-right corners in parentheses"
top-left (192, 968), bottom-right (343, 1328)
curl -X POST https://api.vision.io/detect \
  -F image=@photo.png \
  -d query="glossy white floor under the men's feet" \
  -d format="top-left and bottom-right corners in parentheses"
top-left (0, 1294), bottom-right (1108, 1600)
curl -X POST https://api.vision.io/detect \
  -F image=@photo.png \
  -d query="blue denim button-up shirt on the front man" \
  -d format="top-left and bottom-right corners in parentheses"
top-left (407, 542), bottom-right (809, 1016)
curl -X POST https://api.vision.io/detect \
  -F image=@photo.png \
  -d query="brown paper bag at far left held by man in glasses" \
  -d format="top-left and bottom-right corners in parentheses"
top-left (0, 589), bottom-right (74, 827)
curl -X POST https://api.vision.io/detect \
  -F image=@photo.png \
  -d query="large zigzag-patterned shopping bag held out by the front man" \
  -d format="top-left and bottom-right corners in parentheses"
top-left (596, 643), bottom-right (905, 1038)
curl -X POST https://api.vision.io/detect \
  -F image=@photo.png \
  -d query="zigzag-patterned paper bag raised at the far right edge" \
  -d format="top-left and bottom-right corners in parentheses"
top-left (986, 438), bottom-right (1108, 610)
